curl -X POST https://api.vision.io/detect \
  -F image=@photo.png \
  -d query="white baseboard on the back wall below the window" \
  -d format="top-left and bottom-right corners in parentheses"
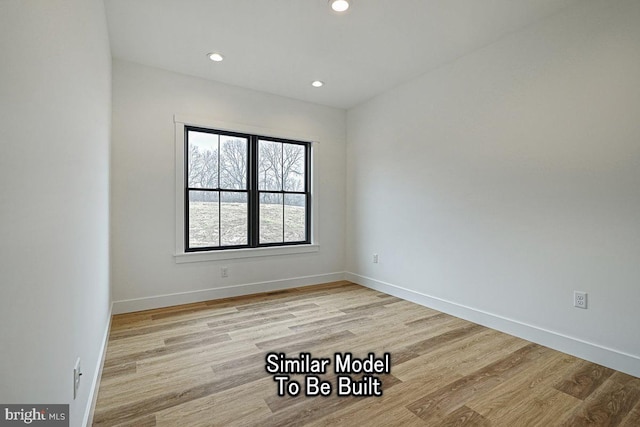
top-left (113, 272), bottom-right (344, 314)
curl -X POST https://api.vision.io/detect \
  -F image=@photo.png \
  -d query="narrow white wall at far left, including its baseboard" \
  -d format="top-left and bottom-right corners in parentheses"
top-left (0, 0), bottom-right (111, 426)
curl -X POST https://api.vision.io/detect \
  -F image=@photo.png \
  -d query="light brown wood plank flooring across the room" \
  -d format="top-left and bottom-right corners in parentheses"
top-left (93, 282), bottom-right (640, 427)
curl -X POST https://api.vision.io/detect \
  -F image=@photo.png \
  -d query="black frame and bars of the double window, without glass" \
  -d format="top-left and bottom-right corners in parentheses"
top-left (183, 125), bottom-right (312, 252)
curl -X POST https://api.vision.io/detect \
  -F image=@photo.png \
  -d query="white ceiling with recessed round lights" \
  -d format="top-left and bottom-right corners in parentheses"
top-left (105, 0), bottom-right (578, 108)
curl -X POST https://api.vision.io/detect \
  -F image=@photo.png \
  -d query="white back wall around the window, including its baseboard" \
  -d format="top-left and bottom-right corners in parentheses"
top-left (111, 60), bottom-right (346, 311)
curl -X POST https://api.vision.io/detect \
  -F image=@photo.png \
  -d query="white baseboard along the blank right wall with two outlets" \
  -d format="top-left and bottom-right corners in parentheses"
top-left (344, 272), bottom-right (640, 377)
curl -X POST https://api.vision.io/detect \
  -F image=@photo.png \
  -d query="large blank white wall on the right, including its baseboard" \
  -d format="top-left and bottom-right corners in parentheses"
top-left (347, 0), bottom-right (640, 375)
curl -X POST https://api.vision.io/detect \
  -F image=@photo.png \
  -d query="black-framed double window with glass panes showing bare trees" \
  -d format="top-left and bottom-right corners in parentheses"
top-left (184, 126), bottom-right (311, 252)
